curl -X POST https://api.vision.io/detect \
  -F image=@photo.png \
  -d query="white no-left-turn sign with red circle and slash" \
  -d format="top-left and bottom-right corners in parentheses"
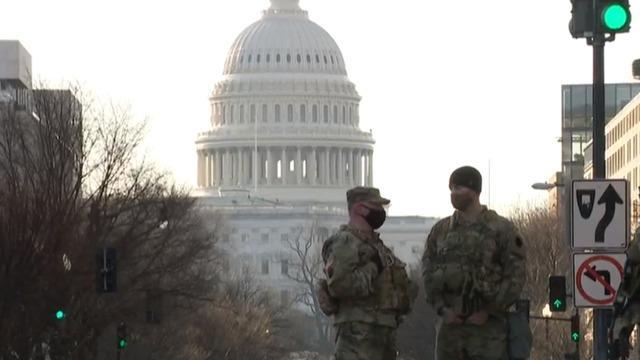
top-left (573, 253), bottom-right (627, 307)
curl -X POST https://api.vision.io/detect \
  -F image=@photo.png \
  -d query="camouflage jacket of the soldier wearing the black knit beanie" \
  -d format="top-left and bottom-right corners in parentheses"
top-left (422, 208), bottom-right (526, 316)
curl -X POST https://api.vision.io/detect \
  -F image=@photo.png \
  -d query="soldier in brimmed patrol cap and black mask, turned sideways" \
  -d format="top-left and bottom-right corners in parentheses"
top-left (317, 187), bottom-right (417, 360)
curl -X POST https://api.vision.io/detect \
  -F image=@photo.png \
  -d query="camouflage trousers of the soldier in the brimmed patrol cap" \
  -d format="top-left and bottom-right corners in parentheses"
top-left (332, 321), bottom-right (397, 360)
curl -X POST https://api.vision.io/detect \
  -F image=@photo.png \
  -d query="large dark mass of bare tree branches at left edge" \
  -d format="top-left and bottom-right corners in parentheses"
top-left (0, 89), bottom-right (219, 359)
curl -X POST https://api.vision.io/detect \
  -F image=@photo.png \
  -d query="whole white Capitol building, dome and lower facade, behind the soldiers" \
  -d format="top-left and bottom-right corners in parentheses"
top-left (196, 0), bottom-right (436, 301)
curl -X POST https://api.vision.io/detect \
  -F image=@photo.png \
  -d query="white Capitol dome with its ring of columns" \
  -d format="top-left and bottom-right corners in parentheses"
top-left (196, 0), bottom-right (374, 203)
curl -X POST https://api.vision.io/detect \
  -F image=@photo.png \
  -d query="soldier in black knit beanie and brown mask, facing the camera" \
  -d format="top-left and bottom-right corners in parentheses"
top-left (422, 166), bottom-right (526, 360)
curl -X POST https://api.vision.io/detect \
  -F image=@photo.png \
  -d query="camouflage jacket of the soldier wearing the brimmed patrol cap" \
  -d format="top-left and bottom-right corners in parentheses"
top-left (322, 225), bottom-right (417, 328)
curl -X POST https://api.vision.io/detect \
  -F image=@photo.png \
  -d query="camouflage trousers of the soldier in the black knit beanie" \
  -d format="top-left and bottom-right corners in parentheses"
top-left (436, 316), bottom-right (508, 360)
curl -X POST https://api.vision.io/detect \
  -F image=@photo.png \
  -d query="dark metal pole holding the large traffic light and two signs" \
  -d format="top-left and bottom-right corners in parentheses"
top-left (593, 20), bottom-right (611, 360)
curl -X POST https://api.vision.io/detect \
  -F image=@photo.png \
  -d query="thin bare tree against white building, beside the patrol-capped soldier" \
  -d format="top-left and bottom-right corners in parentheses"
top-left (287, 222), bottom-right (333, 353)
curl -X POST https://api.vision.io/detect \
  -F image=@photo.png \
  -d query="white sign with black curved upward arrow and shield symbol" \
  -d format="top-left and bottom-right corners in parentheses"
top-left (571, 179), bottom-right (629, 250)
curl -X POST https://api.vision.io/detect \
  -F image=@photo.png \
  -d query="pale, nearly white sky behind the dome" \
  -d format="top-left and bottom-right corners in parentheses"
top-left (0, 0), bottom-right (640, 216)
